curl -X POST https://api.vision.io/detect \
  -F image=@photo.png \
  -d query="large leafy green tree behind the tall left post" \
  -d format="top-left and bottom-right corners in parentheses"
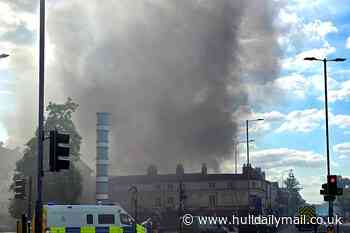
top-left (9, 98), bottom-right (82, 217)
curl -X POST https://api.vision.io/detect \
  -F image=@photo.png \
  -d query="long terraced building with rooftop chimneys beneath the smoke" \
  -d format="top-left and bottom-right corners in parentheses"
top-left (109, 164), bottom-right (278, 224)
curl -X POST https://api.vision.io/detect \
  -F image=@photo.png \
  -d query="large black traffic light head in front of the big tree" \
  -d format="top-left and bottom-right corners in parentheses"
top-left (49, 130), bottom-right (70, 172)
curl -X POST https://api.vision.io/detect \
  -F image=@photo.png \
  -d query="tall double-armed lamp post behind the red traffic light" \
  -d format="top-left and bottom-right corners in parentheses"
top-left (304, 57), bottom-right (346, 217)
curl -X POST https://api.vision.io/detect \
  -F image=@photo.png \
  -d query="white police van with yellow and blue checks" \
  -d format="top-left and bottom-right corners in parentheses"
top-left (42, 205), bottom-right (147, 233)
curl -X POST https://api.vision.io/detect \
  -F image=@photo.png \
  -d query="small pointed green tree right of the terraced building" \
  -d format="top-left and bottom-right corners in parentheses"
top-left (284, 170), bottom-right (305, 215)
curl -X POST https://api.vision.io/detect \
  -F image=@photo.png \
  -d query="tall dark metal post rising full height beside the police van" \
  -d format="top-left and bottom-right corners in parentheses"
top-left (35, 0), bottom-right (45, 233)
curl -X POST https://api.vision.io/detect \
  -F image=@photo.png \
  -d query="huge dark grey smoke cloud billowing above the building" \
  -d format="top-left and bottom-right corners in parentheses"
top-left (43, 0), bottom-right (278, 173)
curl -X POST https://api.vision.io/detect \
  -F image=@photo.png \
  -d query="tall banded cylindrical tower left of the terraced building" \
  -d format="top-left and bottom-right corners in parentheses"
top-left (96, 112), bottom-right (110, 203)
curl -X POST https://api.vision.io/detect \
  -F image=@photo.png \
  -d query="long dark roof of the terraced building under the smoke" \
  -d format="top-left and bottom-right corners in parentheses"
top-left (110, 173), bottom-right (268, 185)
